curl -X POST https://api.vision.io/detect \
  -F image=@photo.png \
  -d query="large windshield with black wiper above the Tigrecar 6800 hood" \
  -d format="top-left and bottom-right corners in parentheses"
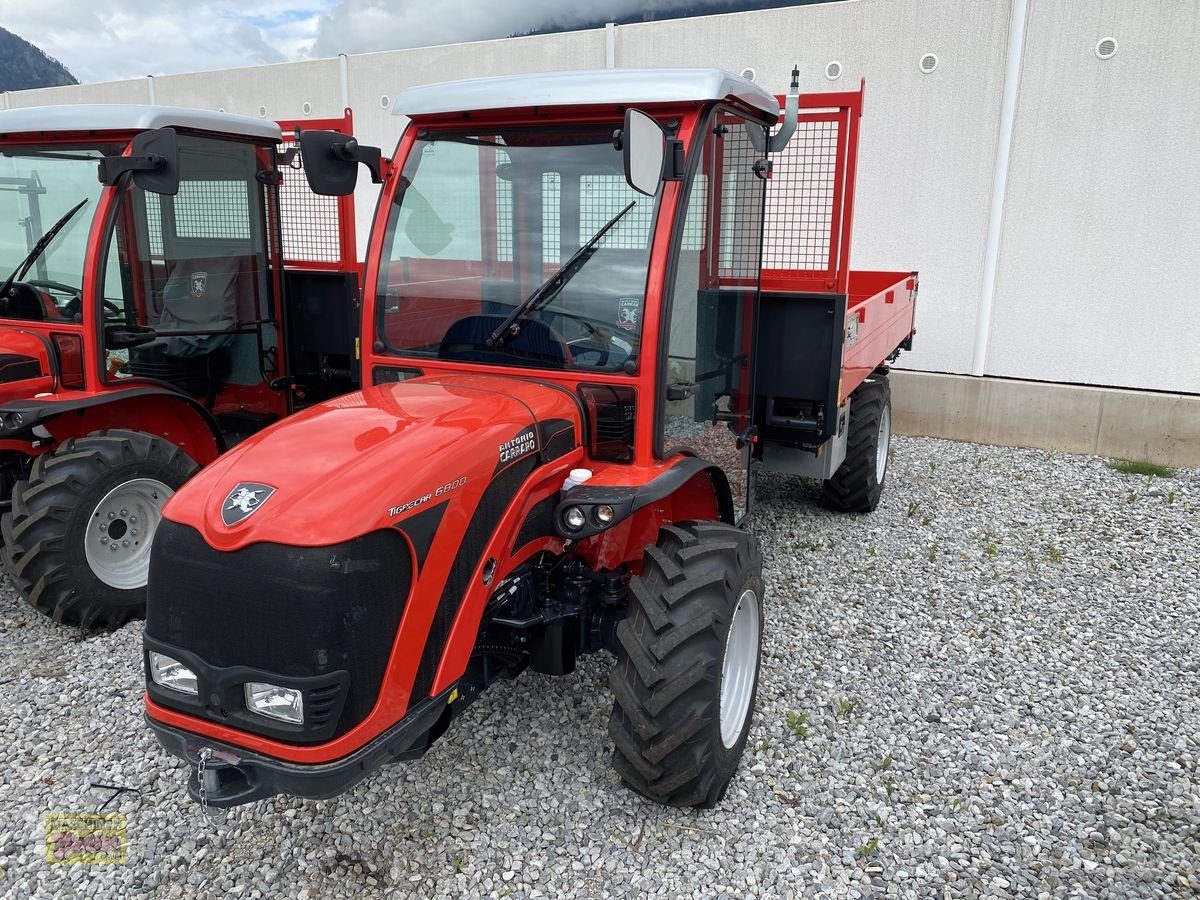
top-left (378, 124), bottom-right (656, 372)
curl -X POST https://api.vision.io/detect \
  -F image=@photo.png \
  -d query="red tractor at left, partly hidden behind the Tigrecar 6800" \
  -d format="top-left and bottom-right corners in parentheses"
top-left (0, 106), bottom-right (360, 628)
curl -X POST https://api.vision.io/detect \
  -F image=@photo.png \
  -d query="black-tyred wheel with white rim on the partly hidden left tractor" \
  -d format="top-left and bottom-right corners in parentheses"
top-left (0, 431), bottom-right (199, 629)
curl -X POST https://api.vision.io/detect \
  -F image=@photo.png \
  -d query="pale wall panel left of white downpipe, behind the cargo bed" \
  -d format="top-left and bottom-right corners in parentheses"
top-left (617, 0), bottom-right (1008, 372)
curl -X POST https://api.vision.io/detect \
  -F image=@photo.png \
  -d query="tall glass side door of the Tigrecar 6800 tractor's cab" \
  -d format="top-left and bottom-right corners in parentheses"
top-left (659, 108), bottom-right (766, 521)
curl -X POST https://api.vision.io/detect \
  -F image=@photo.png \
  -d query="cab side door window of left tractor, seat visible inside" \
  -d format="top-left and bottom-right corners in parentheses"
top-left (102, 137), bottom-right (271, 394)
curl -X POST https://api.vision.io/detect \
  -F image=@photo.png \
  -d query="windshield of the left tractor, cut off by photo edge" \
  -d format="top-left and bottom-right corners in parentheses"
top-left (0, 145), bottom-right (104, 319)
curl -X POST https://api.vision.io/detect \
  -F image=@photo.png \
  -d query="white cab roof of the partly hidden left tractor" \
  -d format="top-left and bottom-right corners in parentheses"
top-left (0, 103), bottom-right (282, 142)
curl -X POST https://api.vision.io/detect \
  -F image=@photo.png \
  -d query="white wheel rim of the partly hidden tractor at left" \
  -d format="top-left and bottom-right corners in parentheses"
top-left (84, 478), bottom-right (175, 590)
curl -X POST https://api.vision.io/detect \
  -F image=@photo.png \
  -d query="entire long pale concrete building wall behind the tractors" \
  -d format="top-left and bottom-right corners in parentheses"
top-left (4, 0), bottom-right (1200, 394)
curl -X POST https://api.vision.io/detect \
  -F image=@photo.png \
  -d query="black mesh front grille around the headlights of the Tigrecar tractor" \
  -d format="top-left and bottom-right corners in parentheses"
top-left (145, 520), bottom-right (413, 743)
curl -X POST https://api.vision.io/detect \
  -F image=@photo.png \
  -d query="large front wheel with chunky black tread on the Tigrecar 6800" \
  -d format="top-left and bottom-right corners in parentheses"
top-left (608, 522), bottom-right (762, 809)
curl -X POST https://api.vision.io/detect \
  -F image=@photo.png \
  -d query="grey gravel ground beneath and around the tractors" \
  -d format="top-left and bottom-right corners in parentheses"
top-left (0, 439), bottom-right (1200, 898)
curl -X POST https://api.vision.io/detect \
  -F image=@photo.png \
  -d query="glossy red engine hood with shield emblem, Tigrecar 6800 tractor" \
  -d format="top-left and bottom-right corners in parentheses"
top-left (163, 376), bottom-right (581, 551)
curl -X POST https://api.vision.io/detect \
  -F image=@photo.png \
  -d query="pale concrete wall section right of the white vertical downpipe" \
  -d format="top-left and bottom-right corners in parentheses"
top-left (986, 0), bottom-right (1200, 394)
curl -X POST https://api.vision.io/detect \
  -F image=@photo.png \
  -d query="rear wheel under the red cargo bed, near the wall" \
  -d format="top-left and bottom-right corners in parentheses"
top-left (822, 374), bottom-right (892, 512)
